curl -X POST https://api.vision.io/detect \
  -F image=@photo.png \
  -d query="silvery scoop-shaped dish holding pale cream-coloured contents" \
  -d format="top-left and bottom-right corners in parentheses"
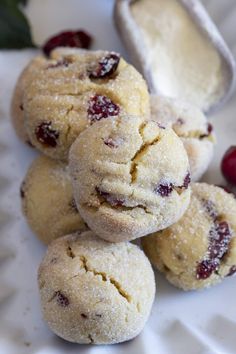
top-left (114, 0), bottom-right (235, 113)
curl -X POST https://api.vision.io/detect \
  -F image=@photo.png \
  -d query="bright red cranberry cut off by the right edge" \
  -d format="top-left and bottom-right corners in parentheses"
top-left (221, 146), bottom-right (236, 185)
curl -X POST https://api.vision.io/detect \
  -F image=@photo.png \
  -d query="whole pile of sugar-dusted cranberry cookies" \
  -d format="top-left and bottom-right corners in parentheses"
top-left (12, 48), bottom-right (236, 344)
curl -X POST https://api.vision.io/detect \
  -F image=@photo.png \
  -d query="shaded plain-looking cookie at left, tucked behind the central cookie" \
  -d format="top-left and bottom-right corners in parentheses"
top-left (21, 156), bottom-right (87, 244)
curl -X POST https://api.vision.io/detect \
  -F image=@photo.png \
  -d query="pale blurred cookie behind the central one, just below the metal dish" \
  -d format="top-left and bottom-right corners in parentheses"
top-left (151, 95), bottom-right (215, 181)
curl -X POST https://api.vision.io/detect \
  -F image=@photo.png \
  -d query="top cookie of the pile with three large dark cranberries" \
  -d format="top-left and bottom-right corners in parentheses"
top-left (23, 48), bottom-right (150, 160)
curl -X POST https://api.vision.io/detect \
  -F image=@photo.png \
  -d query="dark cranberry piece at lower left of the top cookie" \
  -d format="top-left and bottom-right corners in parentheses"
top-left (35, 122), bottom-right (59, 147)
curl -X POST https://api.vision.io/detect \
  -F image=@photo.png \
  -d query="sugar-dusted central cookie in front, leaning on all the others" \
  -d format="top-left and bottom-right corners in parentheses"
top-left (69, 115), bottom-right (190, 242)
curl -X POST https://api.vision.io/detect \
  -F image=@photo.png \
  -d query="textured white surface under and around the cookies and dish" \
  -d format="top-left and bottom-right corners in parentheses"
top-left (0, 0), bottom-right (236, 354)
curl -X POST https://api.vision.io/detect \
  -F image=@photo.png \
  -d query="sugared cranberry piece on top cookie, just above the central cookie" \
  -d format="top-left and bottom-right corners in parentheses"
top-left (87, 95), bottom-right (120, 122)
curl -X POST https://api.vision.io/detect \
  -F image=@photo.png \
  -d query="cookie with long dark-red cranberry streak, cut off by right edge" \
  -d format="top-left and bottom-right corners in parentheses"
top-left (142, 183), bottom-right (236, 290)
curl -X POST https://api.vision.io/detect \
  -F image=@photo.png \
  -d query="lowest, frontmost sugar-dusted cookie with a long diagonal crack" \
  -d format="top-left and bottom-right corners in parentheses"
top-left (38, 231), bottom-right (155, 344)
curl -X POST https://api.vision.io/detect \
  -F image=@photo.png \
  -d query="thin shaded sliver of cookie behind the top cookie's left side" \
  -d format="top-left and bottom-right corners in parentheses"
top-left (11, 57), bottom-right (43, 145)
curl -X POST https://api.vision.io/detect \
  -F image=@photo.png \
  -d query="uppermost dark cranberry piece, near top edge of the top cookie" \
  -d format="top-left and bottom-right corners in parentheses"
top-left (89, 53), bottom-right (120, 79)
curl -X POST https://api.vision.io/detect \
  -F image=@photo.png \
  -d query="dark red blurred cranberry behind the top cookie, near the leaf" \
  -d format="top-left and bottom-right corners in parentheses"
top-left (42, 30), bottom-right (92, 56)
